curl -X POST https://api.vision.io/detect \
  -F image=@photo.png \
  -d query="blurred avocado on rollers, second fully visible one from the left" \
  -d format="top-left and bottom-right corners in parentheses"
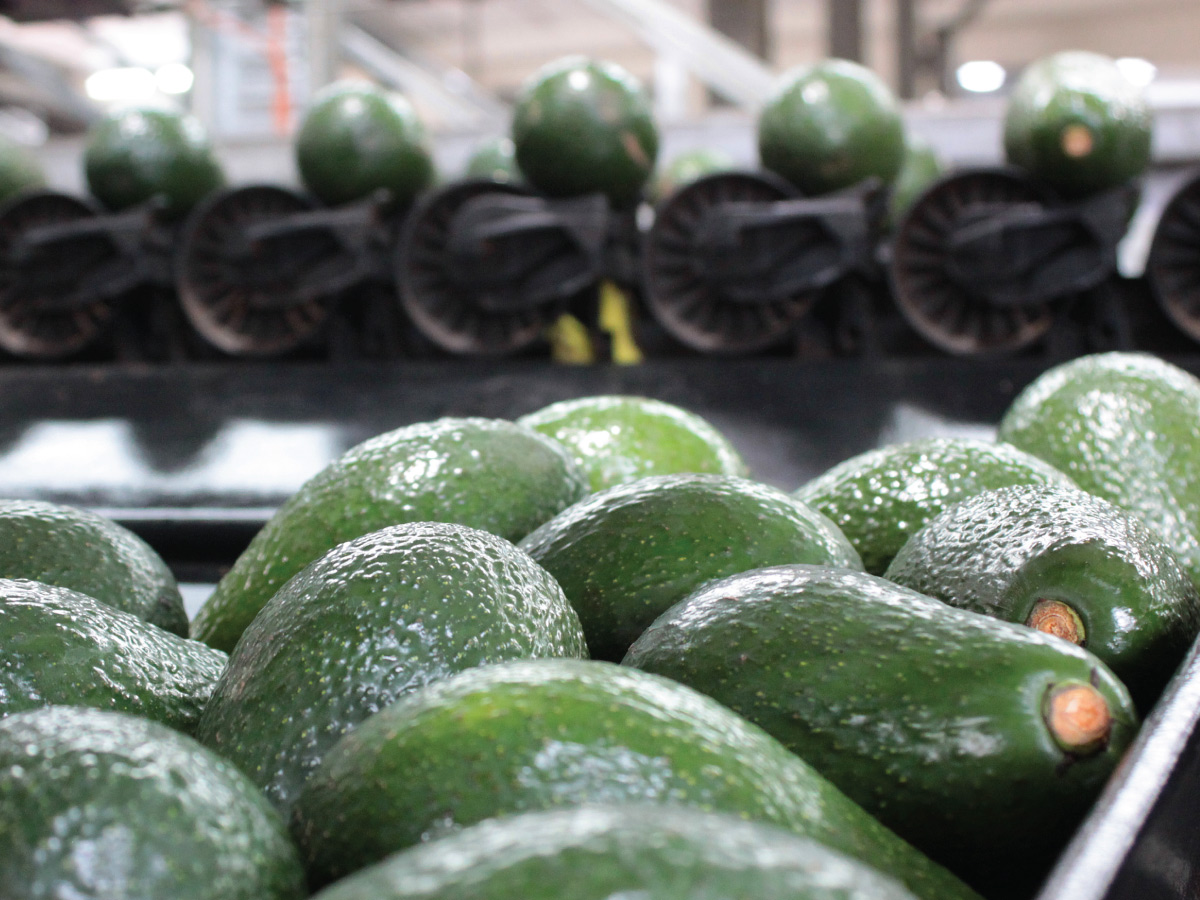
top-left (295, 82), bottom-right (433, 206)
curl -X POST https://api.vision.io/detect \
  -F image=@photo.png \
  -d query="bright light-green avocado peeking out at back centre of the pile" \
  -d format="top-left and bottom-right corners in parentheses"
top-left (517, 395), bottom-right (749, 491)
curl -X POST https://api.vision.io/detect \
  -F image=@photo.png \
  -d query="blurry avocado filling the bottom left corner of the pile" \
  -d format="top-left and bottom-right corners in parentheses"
top-left (0, 707), bottom-right (306, 900)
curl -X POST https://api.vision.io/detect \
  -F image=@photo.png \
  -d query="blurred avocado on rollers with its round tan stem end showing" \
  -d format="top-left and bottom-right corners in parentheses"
top-left (1004, 50), bottom-right (1153, 197)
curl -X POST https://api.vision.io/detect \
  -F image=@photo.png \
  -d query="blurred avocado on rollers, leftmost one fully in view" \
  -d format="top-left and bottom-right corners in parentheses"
top-left (83, 107), bottom-right (224, 217)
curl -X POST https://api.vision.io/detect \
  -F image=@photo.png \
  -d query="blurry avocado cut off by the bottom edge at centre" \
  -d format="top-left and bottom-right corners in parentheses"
top-left (309, 804), bottom-right (917, 900)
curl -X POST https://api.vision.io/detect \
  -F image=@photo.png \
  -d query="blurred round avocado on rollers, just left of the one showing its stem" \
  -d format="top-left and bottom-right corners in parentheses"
top-left (758, 59), bottom-right (905, 196)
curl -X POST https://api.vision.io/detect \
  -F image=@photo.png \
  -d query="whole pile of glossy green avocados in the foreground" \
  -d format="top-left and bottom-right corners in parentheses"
top-left (0, 353), bottom-right (1200, 900)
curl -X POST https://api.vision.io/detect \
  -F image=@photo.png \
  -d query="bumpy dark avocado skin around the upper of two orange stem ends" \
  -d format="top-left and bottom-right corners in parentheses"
top-left (884, 485), bottom-right (1200, 710)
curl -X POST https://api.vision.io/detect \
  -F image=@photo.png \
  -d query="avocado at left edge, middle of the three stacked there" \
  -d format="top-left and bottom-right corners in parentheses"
top-left (0, 578), bottom-right (228, 733)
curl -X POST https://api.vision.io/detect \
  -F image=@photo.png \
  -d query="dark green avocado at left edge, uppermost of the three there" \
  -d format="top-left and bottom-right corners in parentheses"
top-left (0, 500), bottom-right (187, 637)
